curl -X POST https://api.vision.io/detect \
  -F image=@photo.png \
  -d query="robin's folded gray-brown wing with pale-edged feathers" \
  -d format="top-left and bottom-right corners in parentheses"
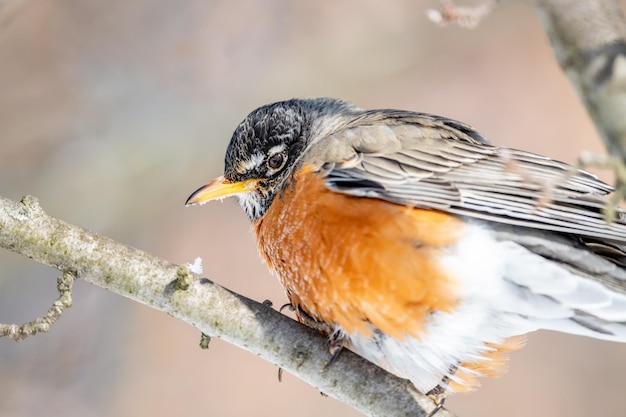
top-left (316, 111), bottom-right (626, 245)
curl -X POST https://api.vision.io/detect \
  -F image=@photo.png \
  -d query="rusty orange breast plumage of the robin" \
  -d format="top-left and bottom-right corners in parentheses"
top-left (254, 169), bottom-right (463, 338)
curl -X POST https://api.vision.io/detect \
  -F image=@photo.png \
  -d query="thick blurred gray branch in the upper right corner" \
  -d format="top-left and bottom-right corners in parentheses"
top-left (534, 0), bottom-right (626, 161)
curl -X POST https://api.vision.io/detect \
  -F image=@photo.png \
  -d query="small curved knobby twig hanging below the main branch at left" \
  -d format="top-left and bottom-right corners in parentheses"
top-left (0, 272), bottom-right (75, 342)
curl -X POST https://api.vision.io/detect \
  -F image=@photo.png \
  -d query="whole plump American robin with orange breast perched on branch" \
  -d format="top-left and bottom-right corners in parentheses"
top-left (187, 98), bottom-right (626, 404)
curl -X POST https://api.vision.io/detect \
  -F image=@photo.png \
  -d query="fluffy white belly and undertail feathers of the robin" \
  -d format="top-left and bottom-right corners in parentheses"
top-left (338, 221), bottom-right (626, 393)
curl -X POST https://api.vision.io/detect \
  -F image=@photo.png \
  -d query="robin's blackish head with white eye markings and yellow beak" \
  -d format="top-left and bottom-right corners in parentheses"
top-left (187, 98), bottom-right (358, 220)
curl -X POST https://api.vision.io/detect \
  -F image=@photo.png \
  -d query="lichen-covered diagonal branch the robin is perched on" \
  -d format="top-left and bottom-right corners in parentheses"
top-left (0, 197), bottom-right (452, 417)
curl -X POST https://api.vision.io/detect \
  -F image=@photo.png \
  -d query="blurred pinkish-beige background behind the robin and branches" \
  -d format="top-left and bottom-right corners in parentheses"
top-left (0, 0), bottom-right (626, 417)
